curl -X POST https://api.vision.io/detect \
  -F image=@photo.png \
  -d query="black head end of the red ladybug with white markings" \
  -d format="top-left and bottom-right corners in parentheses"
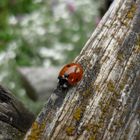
top-left (58, 75), bottom-right (70, 89)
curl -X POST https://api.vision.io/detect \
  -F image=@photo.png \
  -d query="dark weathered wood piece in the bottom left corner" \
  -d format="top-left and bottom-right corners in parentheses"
top-left (0, 85), bottom-right (35, 140)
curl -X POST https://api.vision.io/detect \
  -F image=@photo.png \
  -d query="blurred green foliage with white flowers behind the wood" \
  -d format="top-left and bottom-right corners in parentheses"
top-left (0, 0), bottom-right (100, 113)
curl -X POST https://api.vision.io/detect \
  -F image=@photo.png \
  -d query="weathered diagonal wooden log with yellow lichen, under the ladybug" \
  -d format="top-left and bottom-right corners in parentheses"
top-left (25, 0), bottom-right (140, 140)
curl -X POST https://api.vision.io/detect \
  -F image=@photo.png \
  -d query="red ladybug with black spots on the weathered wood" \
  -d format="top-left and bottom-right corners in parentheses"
top-left (58, 63), bottom-right (83, 88)
